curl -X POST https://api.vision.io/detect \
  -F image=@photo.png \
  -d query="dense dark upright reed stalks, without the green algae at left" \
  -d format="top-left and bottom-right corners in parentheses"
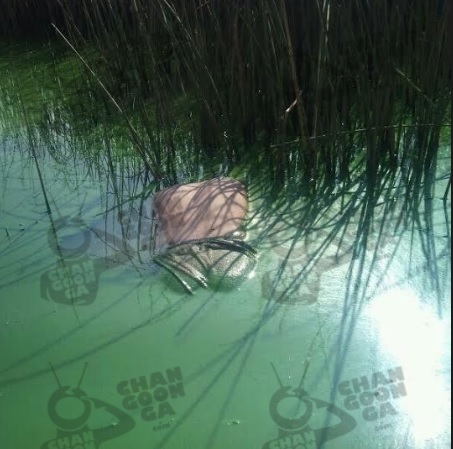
top-left (1, 0), bottom-right (451, 190)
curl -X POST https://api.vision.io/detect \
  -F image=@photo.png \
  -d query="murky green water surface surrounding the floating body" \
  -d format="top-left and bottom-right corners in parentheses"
top-left (0, 130), bottom-right (451, 449)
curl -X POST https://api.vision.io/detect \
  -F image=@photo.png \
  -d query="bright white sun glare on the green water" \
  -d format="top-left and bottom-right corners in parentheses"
top-left (366, 285), bottom-right (451, 447)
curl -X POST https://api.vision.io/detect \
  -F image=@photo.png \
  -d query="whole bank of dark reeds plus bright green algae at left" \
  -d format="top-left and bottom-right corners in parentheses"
top-left (0, 0), bottom-right (451, 300)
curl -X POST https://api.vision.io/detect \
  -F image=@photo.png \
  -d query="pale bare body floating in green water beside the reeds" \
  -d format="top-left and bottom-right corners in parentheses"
top-left (150, 178), bottom-right (252, 293)
